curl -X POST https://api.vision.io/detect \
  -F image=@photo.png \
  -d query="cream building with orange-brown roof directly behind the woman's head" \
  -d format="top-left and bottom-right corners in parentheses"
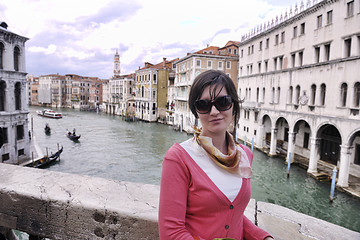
top-left (172, 41), bottom-right (239, 132)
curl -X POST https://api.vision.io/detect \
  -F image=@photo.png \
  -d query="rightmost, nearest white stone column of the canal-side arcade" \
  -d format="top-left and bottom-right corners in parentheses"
top-left (337, 145), bottom-right (351, 187)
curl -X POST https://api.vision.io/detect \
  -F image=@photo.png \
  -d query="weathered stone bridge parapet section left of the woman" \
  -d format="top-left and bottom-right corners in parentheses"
top-left (0, 164), bottom-right (159, 239)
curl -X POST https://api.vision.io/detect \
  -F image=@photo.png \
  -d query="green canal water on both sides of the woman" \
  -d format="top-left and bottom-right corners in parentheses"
top-left (29, 107), bottom-right (360, 232)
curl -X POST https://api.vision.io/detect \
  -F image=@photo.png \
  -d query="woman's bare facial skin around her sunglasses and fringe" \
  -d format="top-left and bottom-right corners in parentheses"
top-left (198, 86), bottom-right (233, 137)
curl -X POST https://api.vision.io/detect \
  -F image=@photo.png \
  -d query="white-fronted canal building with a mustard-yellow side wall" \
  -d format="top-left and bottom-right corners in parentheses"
top-left (135, 58), bottom-right (178, 122)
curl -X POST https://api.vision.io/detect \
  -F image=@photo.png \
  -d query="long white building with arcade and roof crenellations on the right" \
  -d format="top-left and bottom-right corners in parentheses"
top-left (238, 0), bottom-right (360, 187)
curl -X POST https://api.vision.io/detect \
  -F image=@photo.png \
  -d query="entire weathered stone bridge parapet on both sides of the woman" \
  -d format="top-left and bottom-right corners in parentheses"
top-left (0, 163), bottom-right (360, 240)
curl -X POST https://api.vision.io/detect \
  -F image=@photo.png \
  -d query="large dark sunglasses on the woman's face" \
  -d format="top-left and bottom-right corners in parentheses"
top-left (195, 95), bottom-right (233, 114)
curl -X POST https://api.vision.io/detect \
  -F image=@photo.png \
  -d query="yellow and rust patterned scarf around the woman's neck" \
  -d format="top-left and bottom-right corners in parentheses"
top-left (194, 126), bottom-right (251, 178)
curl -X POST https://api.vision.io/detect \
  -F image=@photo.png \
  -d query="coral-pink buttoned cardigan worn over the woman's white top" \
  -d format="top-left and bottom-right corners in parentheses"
top-left (159, 143), bottom-right (270, 240)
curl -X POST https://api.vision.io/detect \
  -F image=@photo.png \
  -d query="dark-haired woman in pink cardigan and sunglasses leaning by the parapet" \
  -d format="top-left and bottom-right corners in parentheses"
top-left (159, 70), bottom-right (272, 240)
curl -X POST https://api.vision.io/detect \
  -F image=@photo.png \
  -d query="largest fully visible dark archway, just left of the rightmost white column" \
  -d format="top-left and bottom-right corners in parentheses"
top-left (316, 123), bottom-right (342, 165)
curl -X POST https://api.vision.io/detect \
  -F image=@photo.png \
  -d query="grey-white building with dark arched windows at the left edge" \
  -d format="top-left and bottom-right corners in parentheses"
top-left (0, 22), bottom-right (30, 164)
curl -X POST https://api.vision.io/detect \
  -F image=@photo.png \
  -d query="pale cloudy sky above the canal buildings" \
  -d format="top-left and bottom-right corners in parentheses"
top-left (0, 0), bottom-right (300, 79)
